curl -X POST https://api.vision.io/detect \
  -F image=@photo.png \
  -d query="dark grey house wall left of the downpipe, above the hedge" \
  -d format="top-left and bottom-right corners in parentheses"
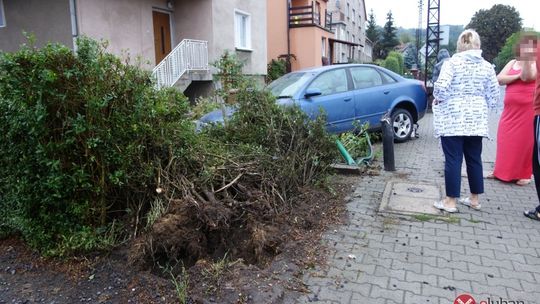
top-left (0, 0), bottom-right (73, 52)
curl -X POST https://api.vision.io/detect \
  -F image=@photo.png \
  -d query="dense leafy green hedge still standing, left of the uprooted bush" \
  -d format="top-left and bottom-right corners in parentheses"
top-left (0, 39), bottom-right (194, 254)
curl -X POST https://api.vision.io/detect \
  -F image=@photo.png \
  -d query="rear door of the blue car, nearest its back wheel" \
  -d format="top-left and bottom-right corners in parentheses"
top-left (350, 66), bottom-right (397, 127)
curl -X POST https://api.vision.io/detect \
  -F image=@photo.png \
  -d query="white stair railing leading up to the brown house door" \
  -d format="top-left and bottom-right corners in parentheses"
top-left (152, 39), bottom-right (208, 88)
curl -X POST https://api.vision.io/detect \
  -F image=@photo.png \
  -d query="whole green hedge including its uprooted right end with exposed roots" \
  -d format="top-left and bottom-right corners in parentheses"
top-left (0, 39), bottom-right (336, 265)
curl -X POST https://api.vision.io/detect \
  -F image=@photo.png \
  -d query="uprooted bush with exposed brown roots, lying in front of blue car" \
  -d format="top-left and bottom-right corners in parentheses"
top-left (131, 89), bottom-right (336, 263)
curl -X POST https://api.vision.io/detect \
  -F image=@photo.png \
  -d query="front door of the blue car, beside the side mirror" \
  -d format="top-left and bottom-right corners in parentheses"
top-left (301, 68), bottom-right (355, 133)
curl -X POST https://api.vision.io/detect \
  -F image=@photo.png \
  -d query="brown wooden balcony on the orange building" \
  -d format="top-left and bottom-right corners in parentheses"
top-left (289, 1), bottom-right (332, 31)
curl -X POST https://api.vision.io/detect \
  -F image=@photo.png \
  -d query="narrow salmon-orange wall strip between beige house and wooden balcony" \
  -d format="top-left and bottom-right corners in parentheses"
top-left (266, 0), bottom-right (288, 62)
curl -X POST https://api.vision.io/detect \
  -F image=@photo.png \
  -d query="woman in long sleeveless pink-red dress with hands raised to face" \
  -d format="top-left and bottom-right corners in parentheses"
top-left (488, 35), bottom-right (536, 186)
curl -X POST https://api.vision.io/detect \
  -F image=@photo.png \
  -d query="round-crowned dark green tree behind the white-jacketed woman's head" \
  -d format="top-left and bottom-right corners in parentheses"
top-left (467, 4), bottom-right (522, 62)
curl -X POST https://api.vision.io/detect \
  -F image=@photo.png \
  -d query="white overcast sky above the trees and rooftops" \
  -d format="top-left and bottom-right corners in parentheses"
top-left (365, 0), bottom-right (540, 31)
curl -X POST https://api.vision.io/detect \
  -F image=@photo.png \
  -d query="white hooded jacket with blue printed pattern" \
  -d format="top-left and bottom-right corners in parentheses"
top-left (433, 50), bottom-right (500, 137)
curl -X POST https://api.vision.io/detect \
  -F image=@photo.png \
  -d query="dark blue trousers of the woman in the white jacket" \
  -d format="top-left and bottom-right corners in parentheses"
top-left (441, 136), bottom-right (484, 197)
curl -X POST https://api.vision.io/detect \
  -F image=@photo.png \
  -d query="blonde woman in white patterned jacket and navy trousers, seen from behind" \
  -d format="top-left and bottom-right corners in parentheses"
top-left (433, 29), bottom-right (499, 212)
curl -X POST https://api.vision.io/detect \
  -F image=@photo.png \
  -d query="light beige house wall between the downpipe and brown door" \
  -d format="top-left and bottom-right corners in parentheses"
top-left (77, 0), bottom-right (167, 68)
